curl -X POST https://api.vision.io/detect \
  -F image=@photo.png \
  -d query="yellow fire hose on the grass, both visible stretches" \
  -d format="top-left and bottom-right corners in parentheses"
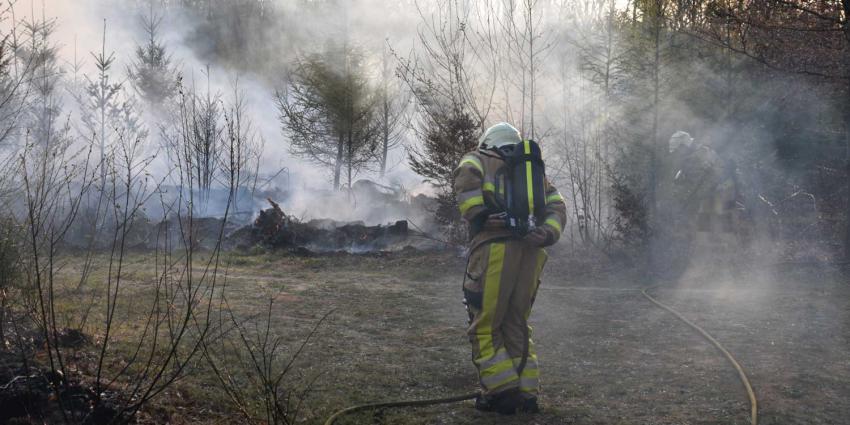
top-left (325, 286), bottom-right (758, 425)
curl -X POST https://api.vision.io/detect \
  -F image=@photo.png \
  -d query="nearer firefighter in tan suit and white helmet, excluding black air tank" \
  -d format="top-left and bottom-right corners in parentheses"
top-left (454, 123), bottom-right (566, 414)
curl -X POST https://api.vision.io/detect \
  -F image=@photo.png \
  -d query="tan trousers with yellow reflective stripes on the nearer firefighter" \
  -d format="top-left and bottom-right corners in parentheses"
top-left (464, 240), bottom-right (547, 395)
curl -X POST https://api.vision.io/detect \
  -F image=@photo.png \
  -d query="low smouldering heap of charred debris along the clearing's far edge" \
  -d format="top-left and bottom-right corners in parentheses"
top-left (64, 189), bottom-right (434, 254)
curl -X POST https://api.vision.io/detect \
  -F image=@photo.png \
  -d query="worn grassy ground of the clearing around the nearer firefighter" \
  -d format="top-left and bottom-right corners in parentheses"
top-left (44, 243), bottom-right (850, 424)
